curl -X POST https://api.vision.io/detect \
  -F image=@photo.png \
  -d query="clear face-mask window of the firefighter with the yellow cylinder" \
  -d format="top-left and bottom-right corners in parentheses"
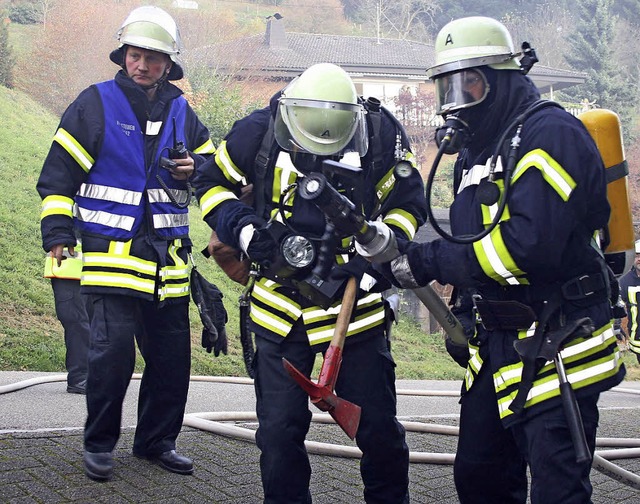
top-left (435, 68), bottom-right (489, 114)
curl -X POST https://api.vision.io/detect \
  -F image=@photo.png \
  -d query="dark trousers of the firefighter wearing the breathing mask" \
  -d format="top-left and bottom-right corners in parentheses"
top-left (454, 362), bottom-right (599, 504)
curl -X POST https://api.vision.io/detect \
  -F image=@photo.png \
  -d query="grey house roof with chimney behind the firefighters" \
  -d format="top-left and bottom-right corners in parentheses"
top-left (197, 17), bottom-right (585, 93)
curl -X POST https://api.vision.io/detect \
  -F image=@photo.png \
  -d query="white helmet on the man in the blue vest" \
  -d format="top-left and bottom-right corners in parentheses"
top-left (109, 5), bottom-right (183, 80)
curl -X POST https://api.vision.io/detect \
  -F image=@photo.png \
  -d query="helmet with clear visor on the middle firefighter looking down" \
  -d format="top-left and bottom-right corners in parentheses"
top-left (274, 63), bottom-right (368, 156)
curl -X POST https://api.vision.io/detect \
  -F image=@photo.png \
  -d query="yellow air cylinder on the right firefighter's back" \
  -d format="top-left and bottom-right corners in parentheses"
top-left (578, 109), bottom-right (635, 276)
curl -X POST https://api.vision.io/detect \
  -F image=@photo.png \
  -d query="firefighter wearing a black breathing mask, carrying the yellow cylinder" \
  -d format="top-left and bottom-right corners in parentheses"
top-left (363, 17), bottom-right (625, 504)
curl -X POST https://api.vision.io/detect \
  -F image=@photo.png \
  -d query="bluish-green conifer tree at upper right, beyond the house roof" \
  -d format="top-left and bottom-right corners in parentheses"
top-left (563, 0), bottom-right (636, 138)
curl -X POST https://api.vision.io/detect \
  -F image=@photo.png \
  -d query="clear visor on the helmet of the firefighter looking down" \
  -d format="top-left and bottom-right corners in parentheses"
top-left (274, 96), bottom-right (368, 157)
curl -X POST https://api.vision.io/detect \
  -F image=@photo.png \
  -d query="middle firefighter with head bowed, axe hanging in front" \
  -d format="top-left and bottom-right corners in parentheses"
top-left (195, 63), bottom-right (426, 504)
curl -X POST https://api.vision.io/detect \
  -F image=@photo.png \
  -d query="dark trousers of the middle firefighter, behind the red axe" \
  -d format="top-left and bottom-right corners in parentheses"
top-left (254, 324), bottom-right (409, 504)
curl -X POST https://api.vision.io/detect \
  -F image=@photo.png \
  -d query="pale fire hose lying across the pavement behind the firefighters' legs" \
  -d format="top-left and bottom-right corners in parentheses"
top-left (0, 373), bottom-right (640, 490)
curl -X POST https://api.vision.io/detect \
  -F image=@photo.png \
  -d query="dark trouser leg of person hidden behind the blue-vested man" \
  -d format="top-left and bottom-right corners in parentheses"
top-left (51, 278), bottom-right (90, 387)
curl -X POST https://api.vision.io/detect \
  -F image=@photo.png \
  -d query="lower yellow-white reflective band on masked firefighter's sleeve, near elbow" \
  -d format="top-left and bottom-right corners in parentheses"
top-left (473, 224), bottom-right (529, 285)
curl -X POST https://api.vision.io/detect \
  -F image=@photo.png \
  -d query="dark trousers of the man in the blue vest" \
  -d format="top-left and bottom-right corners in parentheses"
top-left (84, 295), bottom-right (191, 455)
